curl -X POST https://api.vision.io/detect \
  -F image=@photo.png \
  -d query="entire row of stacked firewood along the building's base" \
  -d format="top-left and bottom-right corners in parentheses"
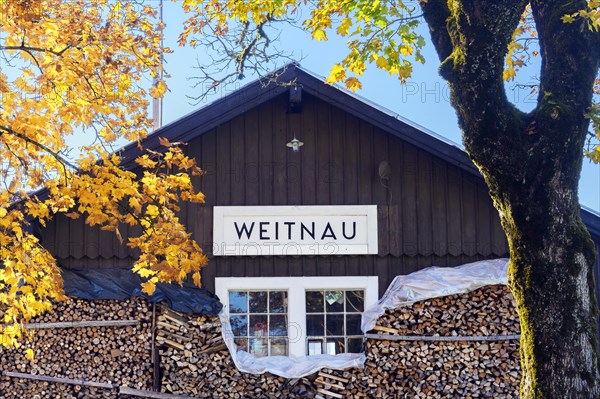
top-left (0, 286), bottom-right (520, 399)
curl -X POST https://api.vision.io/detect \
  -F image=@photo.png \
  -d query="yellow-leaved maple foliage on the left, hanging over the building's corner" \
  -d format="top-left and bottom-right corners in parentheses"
top-left (0, 0), bottom-right (207, 346)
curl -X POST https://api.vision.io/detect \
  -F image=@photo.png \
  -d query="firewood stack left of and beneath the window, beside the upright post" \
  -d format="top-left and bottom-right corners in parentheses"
top-left (156, 309), bottom-right (315, 399)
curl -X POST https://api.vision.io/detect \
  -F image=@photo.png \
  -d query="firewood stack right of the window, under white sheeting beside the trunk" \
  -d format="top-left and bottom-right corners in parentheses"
top-left (316, 286), bottom-right (521, 398)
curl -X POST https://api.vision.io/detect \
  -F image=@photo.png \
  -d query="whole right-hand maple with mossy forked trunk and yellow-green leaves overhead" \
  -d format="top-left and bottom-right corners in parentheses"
top-left (181, 0), bottom-right (600, 399)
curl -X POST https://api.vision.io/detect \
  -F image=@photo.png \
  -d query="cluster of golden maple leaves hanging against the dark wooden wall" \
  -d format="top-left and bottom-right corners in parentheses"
top-left (71, 139), bottom-right (207, 294)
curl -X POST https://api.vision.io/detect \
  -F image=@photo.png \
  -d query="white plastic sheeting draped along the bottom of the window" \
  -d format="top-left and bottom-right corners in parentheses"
top-left (219, 309), bottom-right (366, 378)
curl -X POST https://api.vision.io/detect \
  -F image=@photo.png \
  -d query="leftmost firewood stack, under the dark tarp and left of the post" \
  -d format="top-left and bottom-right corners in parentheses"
top-left (0, 299), bottom-right (152, 399)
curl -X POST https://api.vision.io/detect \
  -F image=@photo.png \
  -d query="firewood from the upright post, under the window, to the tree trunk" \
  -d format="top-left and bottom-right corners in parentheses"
top-left (157, 286), bottom-right (520, 398)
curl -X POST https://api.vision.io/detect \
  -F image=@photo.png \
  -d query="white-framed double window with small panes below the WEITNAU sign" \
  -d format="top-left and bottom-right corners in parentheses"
top-left (215, 276), bottom-right (378, 357)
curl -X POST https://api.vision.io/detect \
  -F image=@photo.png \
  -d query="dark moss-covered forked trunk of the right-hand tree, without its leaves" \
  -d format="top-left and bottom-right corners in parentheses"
top-left (422, 0), bottom-right (600, 399)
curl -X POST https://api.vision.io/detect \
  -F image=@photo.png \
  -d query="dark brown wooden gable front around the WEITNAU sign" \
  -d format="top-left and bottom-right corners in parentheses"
top-left (43, 63), bottom-right (600, 295)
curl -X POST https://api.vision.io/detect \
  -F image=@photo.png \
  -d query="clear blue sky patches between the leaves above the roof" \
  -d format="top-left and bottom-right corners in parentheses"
top-left (157, 1), bottom-right (600, 212)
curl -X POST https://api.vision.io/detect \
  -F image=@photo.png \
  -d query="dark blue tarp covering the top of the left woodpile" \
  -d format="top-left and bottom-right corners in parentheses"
top-left (61, 268), bottom-right (223, 316)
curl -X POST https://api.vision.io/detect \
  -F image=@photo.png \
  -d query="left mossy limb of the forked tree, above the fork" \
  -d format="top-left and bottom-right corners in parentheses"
top-left (422, 0), bottom-right (528, 178)
